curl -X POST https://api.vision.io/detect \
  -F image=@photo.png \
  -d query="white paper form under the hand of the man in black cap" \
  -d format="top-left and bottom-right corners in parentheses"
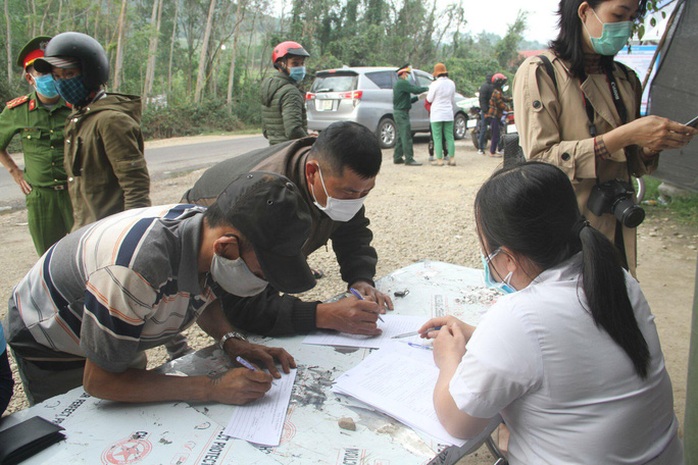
top-left (225, 369), bottom-right (296, 447)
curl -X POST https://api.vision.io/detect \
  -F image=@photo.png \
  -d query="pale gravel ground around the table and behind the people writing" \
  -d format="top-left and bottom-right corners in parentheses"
top-left (0, 138), bottom-right (696, 464)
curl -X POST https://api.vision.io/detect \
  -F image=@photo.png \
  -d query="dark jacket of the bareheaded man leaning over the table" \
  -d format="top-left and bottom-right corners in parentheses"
top-left (182, 137), bottom-right (378, 336)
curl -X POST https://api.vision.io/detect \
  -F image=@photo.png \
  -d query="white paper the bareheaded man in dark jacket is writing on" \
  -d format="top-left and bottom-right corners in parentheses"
top-left (303, 314), bottom-right (429, 349)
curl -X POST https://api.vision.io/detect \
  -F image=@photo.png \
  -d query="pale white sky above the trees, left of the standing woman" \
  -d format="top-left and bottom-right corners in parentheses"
top-left (452, 0), bottom-right (560, 44)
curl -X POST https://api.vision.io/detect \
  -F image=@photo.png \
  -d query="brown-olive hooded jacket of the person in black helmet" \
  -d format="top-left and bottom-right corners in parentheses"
top-left (64, 94), bottom-right (150, 230)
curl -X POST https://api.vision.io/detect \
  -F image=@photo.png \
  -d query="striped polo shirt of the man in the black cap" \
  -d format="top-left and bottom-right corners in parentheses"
top-left (7, 205), bottom-right (216, 372)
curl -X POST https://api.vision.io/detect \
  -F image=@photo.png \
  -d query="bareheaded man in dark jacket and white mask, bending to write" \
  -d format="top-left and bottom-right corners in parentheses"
top-left (182, 122), bottom-right (393, 336)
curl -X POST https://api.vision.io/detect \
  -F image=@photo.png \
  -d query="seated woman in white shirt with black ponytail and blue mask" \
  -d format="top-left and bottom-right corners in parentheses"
top-left (420, 162), bottom-right (683, 465)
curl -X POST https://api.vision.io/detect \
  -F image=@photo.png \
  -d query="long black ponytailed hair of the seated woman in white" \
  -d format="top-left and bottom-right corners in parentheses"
top-left (475, 162), bottom-right (650, 378)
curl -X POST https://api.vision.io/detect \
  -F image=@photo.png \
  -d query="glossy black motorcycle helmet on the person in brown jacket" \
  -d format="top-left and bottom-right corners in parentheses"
top-left (34, 32), bottom-right (109, 90)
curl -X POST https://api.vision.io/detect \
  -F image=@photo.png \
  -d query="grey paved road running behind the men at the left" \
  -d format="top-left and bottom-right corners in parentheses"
top-left (0, 132), bottom-right (267, 211)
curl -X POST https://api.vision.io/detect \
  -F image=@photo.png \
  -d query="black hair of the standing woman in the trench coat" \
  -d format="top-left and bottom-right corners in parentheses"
top-left (550, 0), bottom-right (647, 78)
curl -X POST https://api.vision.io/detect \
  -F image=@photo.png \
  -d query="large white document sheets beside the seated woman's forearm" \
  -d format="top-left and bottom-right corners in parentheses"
top-left (333, 343), bottom-right (465, 446)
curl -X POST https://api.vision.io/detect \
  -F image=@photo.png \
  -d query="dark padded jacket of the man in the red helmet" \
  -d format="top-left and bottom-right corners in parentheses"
top-left (260, 72), bottom-right (308, 145)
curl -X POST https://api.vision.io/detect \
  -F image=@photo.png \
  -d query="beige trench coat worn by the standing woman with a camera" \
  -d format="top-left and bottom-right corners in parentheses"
top-left (514, 51), bottom-right (658, 275)
